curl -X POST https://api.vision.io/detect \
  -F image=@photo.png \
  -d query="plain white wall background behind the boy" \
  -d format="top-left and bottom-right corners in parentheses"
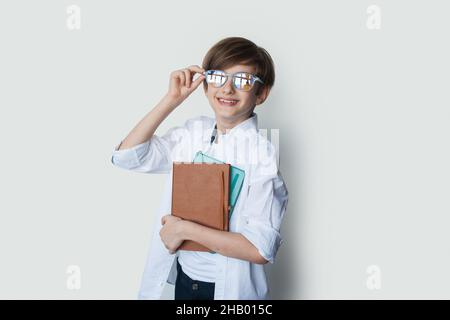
top-left (0, 0), bottom-right (450, 299)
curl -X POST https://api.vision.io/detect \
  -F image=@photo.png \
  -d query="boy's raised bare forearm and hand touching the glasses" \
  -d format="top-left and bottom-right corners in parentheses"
top-left (117, 65), bottom-right (205, 150)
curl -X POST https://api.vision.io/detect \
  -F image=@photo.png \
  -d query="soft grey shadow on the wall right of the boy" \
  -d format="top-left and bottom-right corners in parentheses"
top-left (255, 96), bottom-right (304, 300)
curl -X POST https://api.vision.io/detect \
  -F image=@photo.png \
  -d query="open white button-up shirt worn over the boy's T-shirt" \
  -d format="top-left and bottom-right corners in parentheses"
top-left (111, 113), bottom-right (288, 300)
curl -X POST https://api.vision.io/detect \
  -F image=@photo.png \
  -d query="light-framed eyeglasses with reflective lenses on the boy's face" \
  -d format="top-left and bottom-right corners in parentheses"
top-left (203, 70), bottom-right (264, 91)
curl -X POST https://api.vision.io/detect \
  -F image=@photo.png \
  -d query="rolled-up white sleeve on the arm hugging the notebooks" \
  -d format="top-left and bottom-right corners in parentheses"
top-left (241, 175), bottom-right (288, 263)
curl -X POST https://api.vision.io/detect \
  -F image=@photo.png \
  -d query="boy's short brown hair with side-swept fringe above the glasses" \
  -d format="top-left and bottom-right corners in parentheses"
top-left (202, 37), bottom-right (275, 95)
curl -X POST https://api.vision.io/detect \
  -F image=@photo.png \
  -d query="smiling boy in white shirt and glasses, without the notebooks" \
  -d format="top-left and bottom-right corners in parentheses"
top-left (111, 37), bottom-right (288, 300)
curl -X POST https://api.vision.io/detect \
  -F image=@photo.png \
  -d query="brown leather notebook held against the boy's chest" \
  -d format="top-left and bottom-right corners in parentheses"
top-left (172, 162), bottom-right (230, 252)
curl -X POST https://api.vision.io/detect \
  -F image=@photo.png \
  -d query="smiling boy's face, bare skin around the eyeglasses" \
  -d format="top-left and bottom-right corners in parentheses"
top-left (205, 65), bottom-right (269, 124)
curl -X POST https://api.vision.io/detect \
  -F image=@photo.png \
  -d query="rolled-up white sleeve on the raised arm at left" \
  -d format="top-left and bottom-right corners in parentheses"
top-left (111, 127), bottom-right (187, 173)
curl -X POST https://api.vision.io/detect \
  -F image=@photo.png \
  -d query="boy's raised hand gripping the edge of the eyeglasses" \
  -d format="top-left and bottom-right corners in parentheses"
top-left (166, 65), bottom-right (205, 106)
